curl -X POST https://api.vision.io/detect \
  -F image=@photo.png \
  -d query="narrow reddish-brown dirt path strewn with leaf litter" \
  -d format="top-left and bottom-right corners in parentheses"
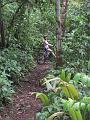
top-left (0, 64), bottom-right (51, 120)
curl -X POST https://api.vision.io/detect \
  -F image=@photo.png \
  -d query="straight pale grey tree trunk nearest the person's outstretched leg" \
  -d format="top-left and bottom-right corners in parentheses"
top-left (56, 0), bottom-right (62, 66)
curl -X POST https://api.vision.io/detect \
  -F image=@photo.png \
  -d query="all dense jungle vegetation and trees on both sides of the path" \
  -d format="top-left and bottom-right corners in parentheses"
top-left (0, 0), bottom-right (90, 120)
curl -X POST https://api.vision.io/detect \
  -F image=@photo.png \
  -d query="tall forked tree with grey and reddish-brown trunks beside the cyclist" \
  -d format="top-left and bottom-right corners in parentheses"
top-left (56, 0), bottom-right (68, 66)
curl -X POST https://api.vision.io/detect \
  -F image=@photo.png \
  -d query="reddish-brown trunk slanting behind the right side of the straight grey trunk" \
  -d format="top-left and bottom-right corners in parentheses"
top-left (61, 0), bottom-right (68, 40)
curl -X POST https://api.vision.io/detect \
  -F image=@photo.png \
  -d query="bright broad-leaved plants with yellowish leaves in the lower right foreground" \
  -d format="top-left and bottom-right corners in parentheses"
top-left (37, 70), bottom-right (90, 120)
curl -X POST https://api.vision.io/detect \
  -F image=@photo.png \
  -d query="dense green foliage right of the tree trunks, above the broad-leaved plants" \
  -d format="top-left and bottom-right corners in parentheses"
top-left (62, 0), bottom-right (90, 73)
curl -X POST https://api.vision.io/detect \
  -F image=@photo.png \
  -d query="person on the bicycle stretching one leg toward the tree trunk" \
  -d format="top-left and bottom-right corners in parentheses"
top-left (43, 35), bottom-right (56, 58)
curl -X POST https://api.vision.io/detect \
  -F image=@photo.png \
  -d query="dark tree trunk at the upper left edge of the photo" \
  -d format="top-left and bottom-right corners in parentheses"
top-left (0, 0), bottom-right (5, 48)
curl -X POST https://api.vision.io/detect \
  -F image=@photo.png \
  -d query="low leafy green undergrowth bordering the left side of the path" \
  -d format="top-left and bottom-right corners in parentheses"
top-left (0, 46), bottom-right (35, 106)
